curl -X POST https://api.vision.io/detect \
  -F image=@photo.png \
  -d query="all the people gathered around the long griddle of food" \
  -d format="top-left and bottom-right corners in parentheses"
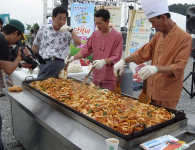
top-left (0, 0), bottom-right (192, 149)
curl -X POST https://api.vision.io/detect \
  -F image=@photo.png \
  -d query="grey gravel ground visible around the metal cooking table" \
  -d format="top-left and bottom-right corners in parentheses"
top-left (0, 58), bottom-right (195, 150)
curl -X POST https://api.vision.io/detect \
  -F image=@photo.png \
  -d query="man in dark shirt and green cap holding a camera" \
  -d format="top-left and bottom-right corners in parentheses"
top-left (0, 19), bottom-right (31, 150)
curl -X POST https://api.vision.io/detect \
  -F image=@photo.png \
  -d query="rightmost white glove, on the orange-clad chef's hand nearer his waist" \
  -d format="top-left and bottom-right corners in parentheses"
top-left (138, 65), bottom-right (158, 80)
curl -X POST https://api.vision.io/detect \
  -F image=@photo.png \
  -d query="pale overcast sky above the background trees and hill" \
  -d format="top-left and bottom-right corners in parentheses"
top-left (0, 0), bottom-right (195, 25)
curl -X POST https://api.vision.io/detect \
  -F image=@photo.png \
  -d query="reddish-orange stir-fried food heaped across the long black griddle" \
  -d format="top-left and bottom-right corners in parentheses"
top-left (30, 78), bottom-right (175, 135)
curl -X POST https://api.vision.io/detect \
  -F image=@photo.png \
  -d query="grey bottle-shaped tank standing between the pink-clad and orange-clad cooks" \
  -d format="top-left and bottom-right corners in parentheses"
top-left (120, 63), bottom-right (133, 96)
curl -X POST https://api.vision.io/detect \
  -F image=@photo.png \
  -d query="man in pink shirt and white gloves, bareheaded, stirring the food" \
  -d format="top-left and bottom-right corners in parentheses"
top-left (66, 9), bottom-right (123, 90)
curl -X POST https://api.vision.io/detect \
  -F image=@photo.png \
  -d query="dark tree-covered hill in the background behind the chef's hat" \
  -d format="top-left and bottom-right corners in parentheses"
top-left (169, 3), bottom-right (195, 16)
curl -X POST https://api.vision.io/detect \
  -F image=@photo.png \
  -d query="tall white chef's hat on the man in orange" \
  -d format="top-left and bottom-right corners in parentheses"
top-left (141, 0), bottom-right (169, 19)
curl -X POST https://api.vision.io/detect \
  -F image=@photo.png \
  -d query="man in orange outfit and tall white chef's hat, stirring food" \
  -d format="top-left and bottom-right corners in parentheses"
top-left (114, 0), bottom-right (192, 109)
